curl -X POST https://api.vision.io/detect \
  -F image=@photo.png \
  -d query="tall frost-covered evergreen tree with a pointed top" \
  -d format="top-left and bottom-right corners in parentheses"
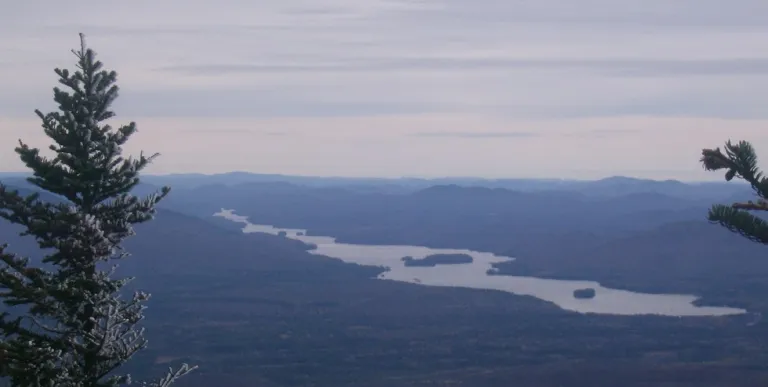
top-left (0, 34), bottom-right (194, 387)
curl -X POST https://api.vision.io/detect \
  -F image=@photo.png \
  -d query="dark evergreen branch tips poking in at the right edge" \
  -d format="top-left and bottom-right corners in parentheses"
top-left (701, 141), bottom-right (768, 244)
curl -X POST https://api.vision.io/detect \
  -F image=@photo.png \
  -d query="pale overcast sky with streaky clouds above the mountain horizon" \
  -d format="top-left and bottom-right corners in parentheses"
top-left (0, 0), bottom-right (768, 180)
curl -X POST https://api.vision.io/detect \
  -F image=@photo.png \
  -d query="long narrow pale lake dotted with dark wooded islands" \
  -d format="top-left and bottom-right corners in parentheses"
top-left (214, 209), bottom-right (746, 316)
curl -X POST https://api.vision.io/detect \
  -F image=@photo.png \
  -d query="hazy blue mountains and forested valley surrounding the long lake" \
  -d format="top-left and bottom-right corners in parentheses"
top-left (0, 173), bottom-right (768, 386)
